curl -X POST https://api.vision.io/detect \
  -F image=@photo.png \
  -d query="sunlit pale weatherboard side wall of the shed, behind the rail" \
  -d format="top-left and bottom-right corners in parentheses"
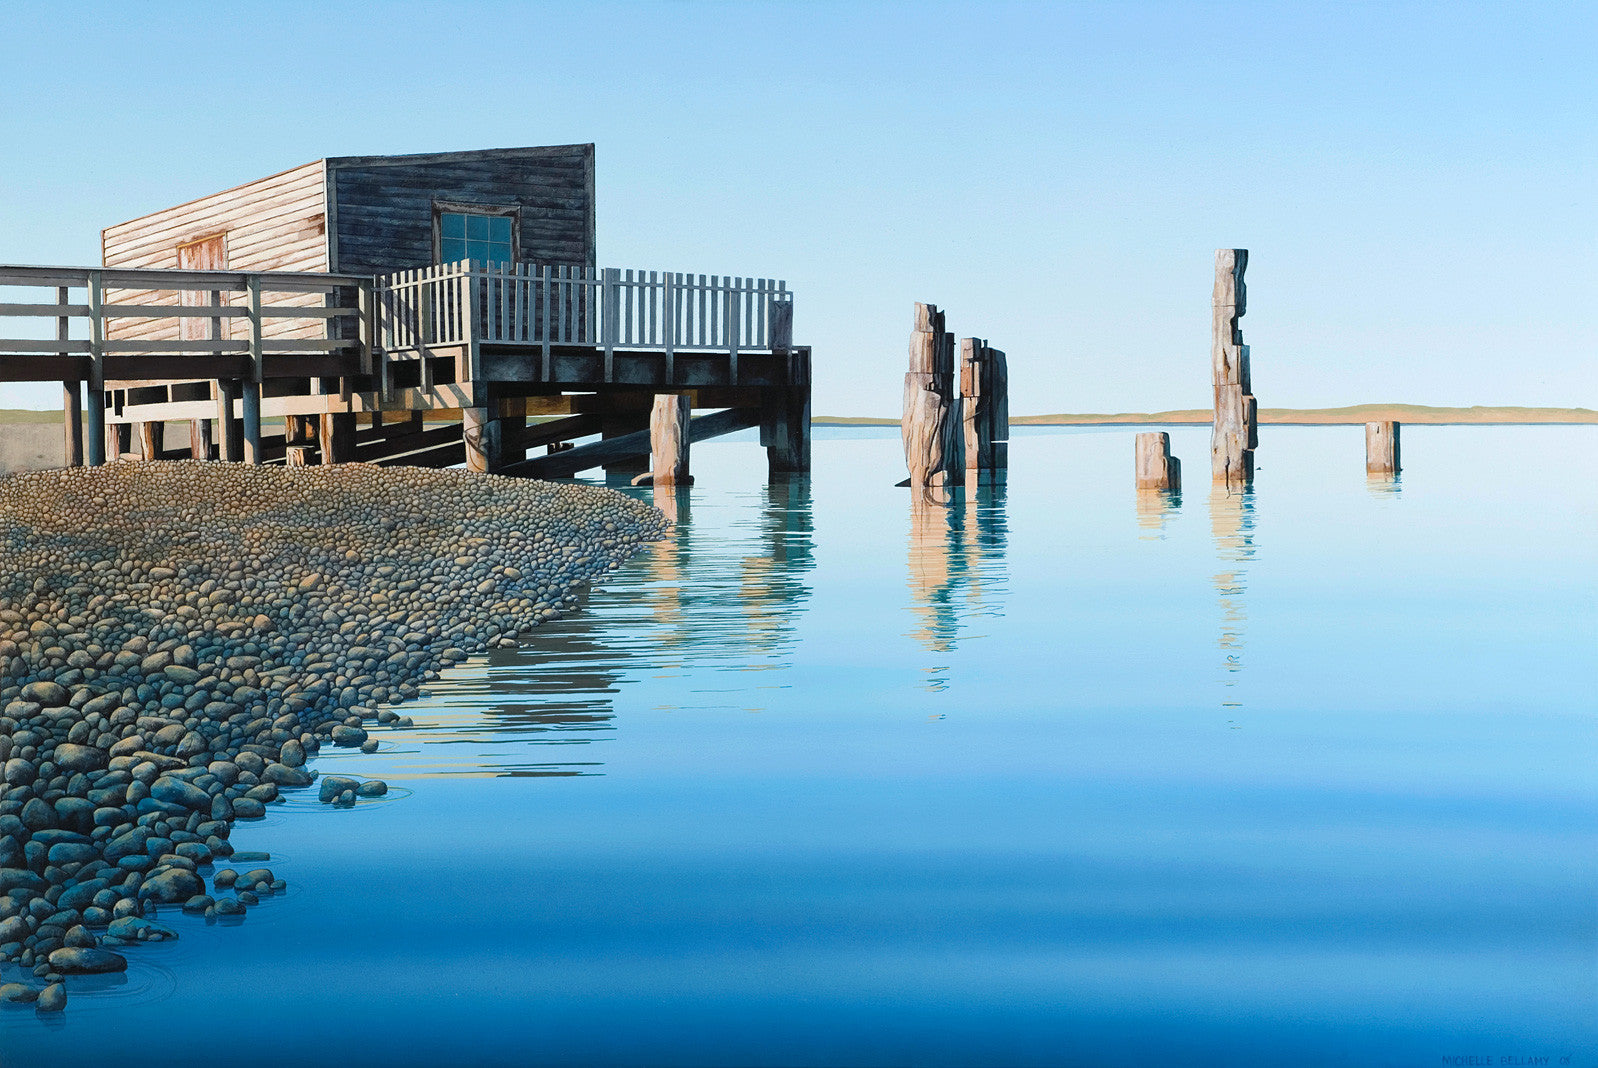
top-left (101, 160), bottom-right (329, 341)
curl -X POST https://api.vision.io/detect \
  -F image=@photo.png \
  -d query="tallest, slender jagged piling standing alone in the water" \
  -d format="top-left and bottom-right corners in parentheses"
top-left (1210, 248), bottom-right (1259, 484)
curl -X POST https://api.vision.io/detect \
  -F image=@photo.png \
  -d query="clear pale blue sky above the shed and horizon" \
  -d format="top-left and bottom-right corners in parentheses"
top-left (0, 0), bottom-right (1598, 414)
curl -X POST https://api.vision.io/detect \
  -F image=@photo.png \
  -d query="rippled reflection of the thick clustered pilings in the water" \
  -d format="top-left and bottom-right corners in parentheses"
top-left (908, 481), bottom-right (1008, 691)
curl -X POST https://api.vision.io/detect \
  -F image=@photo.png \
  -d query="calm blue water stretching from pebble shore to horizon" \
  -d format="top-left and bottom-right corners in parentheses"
top-left (0, 427), bottom-right (1598, 1068)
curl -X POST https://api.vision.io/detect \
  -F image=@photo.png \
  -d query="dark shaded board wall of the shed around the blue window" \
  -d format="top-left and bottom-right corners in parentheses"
top-left (328, 144), bottom-right (594, 275)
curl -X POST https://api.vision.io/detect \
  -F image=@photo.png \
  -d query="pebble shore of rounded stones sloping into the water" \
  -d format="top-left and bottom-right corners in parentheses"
top-left (0, 462), bottom-right (668, 1012)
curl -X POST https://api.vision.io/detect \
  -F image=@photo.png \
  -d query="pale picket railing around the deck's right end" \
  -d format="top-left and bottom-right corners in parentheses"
top-left (376, 261), bottom-right (793, 378)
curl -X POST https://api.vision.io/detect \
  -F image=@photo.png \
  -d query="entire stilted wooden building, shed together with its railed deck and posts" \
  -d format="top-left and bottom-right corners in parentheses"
top-left (9, 144), bottom-right (810, 481)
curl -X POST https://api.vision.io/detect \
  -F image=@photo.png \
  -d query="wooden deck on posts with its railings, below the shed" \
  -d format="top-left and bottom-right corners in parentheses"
top-left (0, 261), bottom-right (810, 476)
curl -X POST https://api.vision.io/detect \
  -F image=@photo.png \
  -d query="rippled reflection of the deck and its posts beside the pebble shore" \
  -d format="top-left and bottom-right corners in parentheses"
top-left (380, 476), bottom-right (815, 779)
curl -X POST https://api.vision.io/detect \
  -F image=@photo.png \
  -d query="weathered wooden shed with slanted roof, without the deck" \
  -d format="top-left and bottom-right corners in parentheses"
top-left (101, 144), bottom-right (594, 341)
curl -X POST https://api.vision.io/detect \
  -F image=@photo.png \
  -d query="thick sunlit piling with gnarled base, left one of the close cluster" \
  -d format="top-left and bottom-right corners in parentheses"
top-left (900, 304), bottom-right (965, 494)
